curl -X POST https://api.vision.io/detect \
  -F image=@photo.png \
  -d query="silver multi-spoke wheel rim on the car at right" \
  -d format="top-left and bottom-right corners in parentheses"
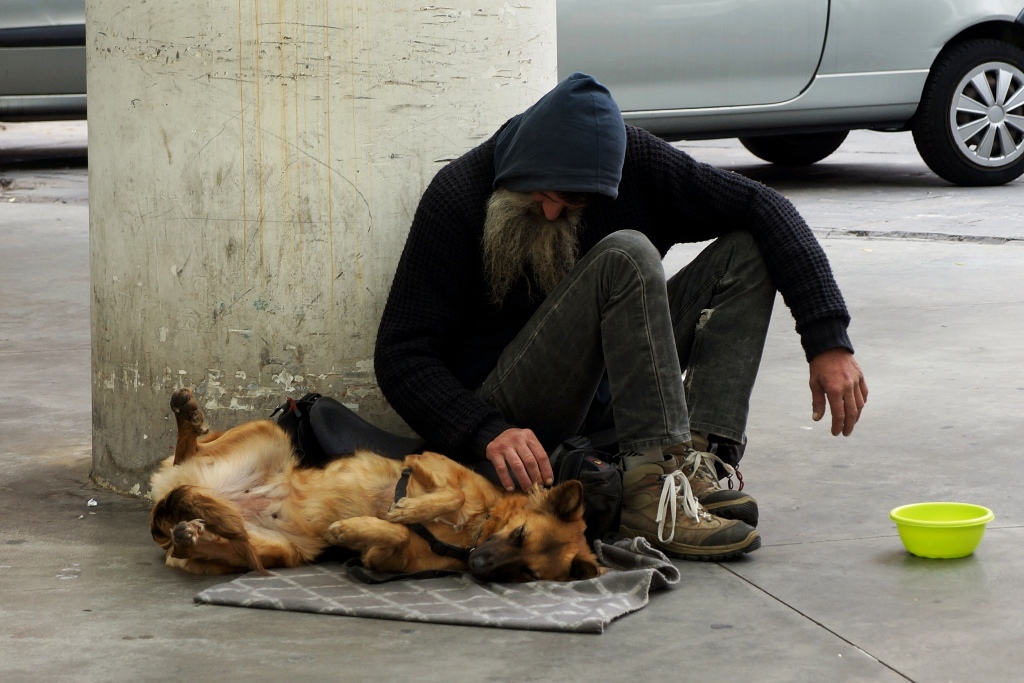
top-left (949, 61), bottom-right (1024, 168)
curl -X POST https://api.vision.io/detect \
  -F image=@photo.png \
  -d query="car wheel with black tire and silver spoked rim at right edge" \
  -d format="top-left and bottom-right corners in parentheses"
top-left (912, 40), bottom-right (1024, 185)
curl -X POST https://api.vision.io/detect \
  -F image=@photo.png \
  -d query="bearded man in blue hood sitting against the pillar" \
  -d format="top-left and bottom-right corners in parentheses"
top-left (375, 74), bottom-right (867, 559)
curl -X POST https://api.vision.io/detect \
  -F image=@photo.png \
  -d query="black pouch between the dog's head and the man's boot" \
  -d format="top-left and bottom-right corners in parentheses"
top-left (550, 436), bottom-right (623, 545)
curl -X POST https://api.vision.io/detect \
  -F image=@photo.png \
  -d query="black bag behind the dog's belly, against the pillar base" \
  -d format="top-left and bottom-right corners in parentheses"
top-left (270, 393), bottom-right (423, 468)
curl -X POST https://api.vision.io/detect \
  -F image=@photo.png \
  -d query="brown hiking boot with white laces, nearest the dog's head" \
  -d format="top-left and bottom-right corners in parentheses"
top-left (618, 460), bottom-right (761, 561)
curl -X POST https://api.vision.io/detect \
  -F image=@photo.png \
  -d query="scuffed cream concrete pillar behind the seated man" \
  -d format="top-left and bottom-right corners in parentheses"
top-left (86, 0), bottom-right (556, 493)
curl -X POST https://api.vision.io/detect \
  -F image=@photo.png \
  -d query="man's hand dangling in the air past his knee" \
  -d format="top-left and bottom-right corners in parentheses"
top-left (810, 348), bottom-right (867, 436)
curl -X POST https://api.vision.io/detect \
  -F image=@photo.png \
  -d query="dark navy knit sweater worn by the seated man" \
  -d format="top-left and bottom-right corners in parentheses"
top-left (374, 126), bottom-right (853, 462)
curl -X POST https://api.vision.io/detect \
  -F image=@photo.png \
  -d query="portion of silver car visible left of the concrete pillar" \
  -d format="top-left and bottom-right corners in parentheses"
top-left (0, 0), bottom-right (85, 121)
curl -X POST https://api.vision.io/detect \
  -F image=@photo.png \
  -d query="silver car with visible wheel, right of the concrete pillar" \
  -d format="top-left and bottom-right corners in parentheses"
top-left (558, 0), bottom-right (1024, 185)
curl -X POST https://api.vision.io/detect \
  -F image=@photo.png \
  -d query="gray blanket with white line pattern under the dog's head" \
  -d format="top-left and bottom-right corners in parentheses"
top-left (196, 539), bottom-right (679, 633)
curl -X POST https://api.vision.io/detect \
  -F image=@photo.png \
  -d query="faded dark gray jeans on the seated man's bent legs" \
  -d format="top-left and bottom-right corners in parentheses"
top-left (478, 230), bottom-right (775, 452)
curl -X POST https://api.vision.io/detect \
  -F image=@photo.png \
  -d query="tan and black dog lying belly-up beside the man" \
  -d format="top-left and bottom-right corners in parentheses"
top-left (151, 389), bottom-right (602, 582)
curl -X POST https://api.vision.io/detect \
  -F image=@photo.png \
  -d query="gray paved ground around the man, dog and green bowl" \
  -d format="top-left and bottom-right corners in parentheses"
top-left (0, 124), bottom-right (1024, 683)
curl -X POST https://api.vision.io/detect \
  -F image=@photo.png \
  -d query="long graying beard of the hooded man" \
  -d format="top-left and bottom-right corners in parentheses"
top-left (483, 187), bottom-right (583, 305)
